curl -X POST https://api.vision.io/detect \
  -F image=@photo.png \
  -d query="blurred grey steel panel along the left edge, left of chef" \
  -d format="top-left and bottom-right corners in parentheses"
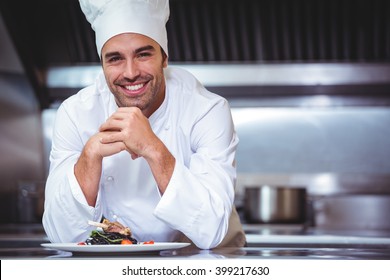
top-left (0, 12), bottom-right (45, 223)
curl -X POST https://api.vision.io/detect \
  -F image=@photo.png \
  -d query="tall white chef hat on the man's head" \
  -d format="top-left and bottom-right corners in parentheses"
top-left (79, 0), bottom-right (169, 56)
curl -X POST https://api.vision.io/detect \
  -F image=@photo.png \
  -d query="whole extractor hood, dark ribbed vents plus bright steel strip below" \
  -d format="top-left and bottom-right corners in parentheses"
top-left (0, 0), bottom-right (390, 108)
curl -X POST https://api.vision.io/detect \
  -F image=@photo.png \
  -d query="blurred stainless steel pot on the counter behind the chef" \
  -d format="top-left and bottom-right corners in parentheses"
top-left (244, 185), bottom-right (307, 224)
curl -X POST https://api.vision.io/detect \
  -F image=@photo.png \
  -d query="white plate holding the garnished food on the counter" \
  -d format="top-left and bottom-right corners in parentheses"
top-left (41, 242), bottom-right (191, 253)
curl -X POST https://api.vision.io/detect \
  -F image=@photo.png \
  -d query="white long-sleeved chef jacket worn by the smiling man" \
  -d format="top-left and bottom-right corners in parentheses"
top-left (43, 67), bottom-right (238, 248)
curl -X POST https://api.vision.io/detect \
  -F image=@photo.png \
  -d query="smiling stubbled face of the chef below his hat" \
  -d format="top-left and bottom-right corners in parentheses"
top-left (102, 33), bottom-right (167, 117)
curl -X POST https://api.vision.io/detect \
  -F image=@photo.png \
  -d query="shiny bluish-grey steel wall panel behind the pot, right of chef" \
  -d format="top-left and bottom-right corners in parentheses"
top-left (233, 107), bottom-right (390, 195)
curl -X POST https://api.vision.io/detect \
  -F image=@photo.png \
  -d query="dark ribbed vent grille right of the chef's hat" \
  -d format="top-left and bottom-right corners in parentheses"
top-left (168, 0), bottom-right (390, 62)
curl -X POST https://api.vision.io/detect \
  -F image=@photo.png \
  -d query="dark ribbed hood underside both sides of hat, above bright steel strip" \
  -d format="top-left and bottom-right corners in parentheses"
top-left (0, 0), bottom-right (390, 108)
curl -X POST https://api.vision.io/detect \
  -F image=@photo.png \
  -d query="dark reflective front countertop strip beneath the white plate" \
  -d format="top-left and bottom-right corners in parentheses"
top-left (0, 246), bottom-right (390, 260)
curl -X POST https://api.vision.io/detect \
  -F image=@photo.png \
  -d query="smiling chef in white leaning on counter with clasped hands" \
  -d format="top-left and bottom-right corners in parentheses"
top-left (43, 0), bottom-right (245, 249)
